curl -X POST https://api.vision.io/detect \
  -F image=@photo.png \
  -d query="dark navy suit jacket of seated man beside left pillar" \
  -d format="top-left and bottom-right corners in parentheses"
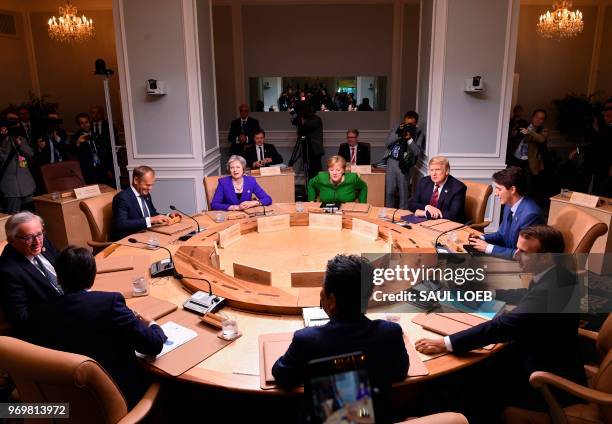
top-left (111, 187), bottom-right (159, 240)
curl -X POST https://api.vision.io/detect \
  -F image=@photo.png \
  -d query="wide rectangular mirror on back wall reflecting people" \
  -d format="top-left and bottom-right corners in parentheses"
top-left (249, 76), bottom-right (387, 112)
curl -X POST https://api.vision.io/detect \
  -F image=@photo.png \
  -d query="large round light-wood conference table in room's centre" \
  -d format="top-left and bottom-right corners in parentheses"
top-left (94, 203), bottom-right (502, 395)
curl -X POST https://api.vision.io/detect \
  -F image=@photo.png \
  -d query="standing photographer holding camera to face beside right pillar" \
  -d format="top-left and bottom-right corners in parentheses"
top-left (383, 125), bottom-right (421, 209)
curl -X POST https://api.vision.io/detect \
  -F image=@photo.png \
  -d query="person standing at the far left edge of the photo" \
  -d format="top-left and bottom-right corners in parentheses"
top-left (0, 113), bottom-right (36, 215)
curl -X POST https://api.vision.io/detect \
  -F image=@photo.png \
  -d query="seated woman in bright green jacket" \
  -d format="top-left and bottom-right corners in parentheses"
top-left (308, 156), bottom-right (368, 203)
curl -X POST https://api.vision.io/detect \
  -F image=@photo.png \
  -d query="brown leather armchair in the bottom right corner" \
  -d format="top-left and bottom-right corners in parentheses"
top-left (504, 315), bottom-right (612, 424)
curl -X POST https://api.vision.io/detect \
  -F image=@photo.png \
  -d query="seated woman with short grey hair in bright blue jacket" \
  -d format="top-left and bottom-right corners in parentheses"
top-left (210, 155), bottom-right (272, 211)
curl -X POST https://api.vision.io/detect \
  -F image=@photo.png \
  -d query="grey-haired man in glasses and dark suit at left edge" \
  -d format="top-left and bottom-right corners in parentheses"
top-left (0, 212), bottom-right (63, 332)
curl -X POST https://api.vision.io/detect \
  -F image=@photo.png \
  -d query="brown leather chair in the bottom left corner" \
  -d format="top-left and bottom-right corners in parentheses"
top-left (0, 336), bottom-right (160, 424)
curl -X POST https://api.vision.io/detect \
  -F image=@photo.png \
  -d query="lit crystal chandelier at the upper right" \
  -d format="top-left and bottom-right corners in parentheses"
top-left (538, 0), bottom-right (584, 40)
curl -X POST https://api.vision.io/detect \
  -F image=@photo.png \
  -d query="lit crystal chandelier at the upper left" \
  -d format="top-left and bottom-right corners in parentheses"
top-left (48, 0), bottom-right (94, 43)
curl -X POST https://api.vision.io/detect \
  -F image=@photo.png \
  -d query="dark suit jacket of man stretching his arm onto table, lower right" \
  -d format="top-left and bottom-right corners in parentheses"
top-left (450, 266), bottom-right (585, 396)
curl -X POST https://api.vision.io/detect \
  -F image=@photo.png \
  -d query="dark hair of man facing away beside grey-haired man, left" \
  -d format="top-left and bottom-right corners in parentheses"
top-left (54, 246), bottom-right (96, 293)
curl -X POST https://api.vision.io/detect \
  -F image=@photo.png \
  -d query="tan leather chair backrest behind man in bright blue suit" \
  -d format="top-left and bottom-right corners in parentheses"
top-left (548, 205), bottom-right (608, 253)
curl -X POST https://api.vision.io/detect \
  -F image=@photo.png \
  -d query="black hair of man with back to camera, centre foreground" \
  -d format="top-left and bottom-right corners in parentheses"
top-left (323, 255), bottom-right (374, 318)
